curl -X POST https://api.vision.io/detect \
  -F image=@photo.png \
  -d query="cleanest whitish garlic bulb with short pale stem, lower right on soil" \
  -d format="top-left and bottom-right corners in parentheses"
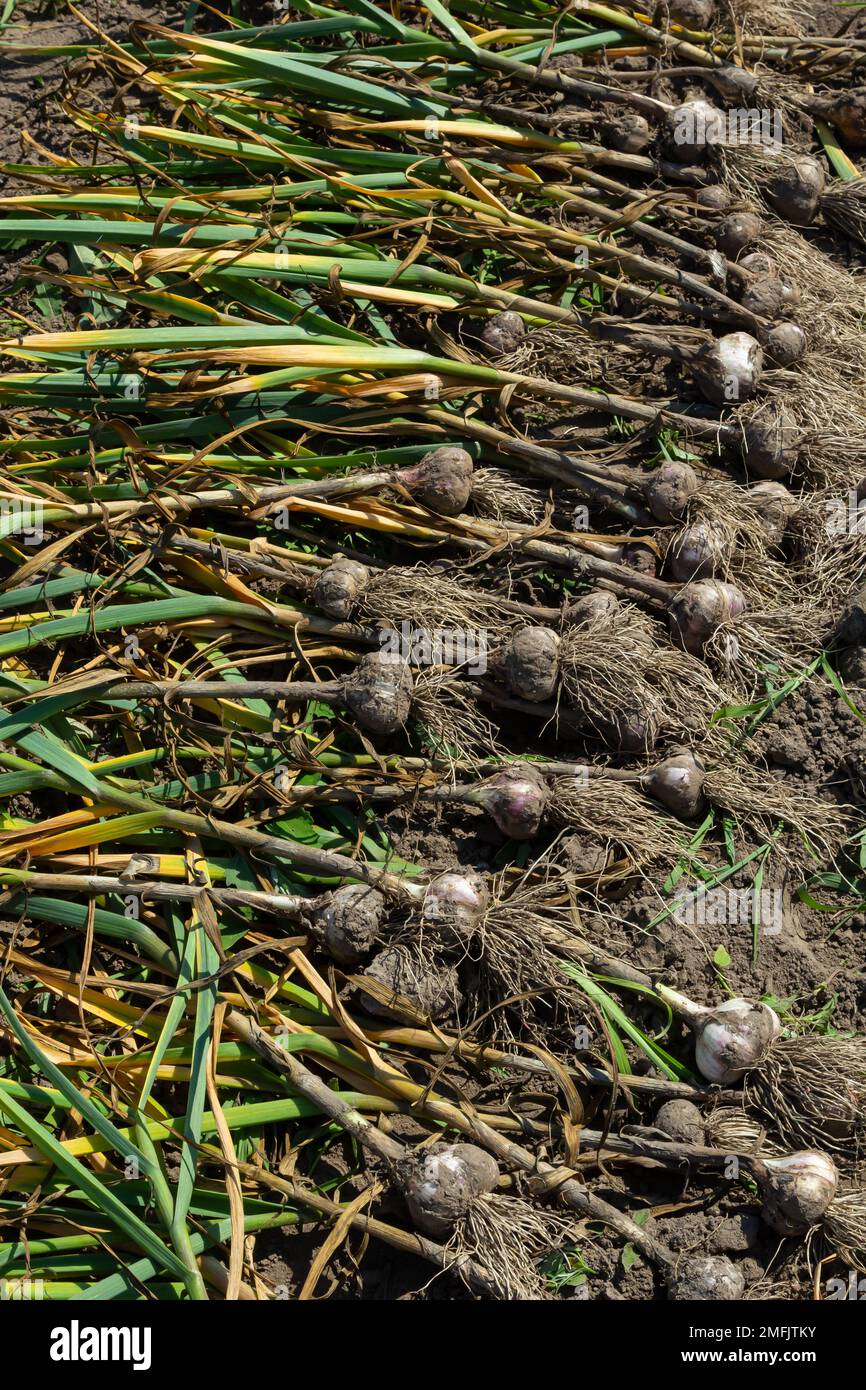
top-left (657, 984), bottom-right (781, 1086)
